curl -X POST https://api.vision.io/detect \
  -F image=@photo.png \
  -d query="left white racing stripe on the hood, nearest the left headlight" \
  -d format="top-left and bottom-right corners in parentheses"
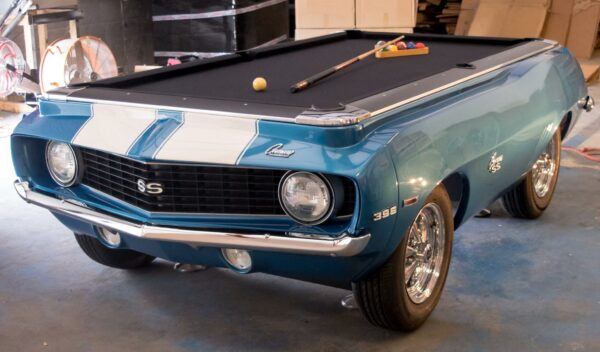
top-left (72, 104), bottom-right (156, 155)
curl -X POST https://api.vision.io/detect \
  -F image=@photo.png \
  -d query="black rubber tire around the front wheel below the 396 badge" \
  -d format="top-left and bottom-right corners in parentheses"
top-left (352, 185), bottom-right (454, 331)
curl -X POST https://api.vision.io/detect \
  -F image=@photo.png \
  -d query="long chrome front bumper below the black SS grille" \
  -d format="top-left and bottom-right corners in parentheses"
top-left (14, 180), bottom-right (371, 257)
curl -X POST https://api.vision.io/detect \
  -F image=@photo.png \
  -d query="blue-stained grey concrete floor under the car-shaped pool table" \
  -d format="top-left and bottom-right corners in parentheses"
top-left (0, 86), bottom-right (600, 351)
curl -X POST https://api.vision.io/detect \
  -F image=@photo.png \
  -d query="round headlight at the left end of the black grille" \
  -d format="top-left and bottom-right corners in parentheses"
top-left (46, 142), bottom-right (77, 186)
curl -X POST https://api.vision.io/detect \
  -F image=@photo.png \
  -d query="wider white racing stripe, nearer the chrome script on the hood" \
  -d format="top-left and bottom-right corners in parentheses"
top-left (155, 112), bottom-right (256, 165)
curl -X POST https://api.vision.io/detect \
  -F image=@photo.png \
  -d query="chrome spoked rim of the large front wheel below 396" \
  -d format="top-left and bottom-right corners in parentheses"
top-left (404, 203), bottom-right (446, 304)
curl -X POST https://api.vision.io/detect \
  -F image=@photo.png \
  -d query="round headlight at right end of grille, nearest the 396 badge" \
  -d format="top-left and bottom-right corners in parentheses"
top-left (279, 172), bottom-right (334, 225)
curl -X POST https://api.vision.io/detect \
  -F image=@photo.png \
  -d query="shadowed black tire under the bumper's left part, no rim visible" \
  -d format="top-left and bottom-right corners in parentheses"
top-left (75, 234), bottom-right (155, 269)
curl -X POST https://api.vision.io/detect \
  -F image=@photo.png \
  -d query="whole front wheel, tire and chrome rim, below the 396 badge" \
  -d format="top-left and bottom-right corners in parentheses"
top-left (352, 186), bottom-right (454, 331)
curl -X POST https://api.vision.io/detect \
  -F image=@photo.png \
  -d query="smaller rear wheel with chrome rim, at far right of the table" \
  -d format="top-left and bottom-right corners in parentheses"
top-left (501, 130), bottom-right (561, 219)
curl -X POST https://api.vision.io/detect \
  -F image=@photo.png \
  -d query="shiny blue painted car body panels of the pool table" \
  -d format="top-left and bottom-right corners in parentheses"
top-left (12, 40), bottom-right (587, 288)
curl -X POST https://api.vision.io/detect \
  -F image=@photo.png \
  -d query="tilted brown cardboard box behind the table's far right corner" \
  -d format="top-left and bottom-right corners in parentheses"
top-left (468, 0), bottom-right (548, 38)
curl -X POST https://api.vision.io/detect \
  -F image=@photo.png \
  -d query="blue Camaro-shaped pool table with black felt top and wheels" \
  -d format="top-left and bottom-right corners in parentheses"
top-left (12, 31), bottom-right (593, 330)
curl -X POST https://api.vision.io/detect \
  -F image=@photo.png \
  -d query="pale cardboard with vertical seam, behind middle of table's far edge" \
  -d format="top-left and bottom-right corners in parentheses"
top-left (296, 0), bottom-right (416, 39)
